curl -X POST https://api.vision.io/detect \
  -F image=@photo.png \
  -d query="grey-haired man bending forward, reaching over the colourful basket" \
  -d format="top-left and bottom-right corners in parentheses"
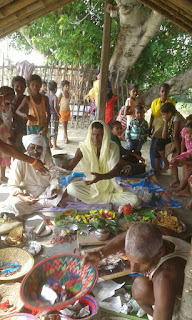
top-left (84, 222), bottom-right (190, 320)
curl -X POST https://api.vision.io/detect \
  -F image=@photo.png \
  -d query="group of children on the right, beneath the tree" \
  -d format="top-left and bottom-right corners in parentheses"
top-left (106, 83), bottom-right (192, 209)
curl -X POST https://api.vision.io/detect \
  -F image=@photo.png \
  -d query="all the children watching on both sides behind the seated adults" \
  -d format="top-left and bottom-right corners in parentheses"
top-left (0, 74), bottom-right (192, 208)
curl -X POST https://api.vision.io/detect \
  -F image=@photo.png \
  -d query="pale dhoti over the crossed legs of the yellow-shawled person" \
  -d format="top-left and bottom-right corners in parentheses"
top-left (67, 181), bottom-right (140, 207)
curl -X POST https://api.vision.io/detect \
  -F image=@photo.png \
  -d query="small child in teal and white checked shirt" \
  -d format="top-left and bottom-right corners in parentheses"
top-left (125, 105), bottom-right (149, 155)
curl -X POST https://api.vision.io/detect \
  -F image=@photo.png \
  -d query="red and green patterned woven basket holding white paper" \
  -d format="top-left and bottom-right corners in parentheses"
top-left (20, 254), bottom-right (98, 311)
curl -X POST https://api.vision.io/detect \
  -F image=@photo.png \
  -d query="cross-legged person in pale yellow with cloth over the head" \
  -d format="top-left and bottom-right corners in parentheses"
top-left (65, 121), bottom-right (140, 207)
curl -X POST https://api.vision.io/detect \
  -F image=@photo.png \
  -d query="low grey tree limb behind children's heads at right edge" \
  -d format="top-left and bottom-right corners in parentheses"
top-left (143, 68), bottom-right (192, 106)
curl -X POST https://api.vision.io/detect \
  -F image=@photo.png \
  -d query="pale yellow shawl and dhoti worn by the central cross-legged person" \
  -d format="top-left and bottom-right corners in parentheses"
top-left (67, 120), bottom-right (140, 207)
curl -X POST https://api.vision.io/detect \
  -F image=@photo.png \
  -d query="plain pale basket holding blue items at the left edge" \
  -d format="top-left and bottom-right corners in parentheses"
top-left (0, 248), bottom-right (34, 280)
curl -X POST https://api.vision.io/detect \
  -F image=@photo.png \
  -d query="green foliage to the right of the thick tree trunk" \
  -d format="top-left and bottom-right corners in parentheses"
top-left (128, 21), bottom-right (192, 90)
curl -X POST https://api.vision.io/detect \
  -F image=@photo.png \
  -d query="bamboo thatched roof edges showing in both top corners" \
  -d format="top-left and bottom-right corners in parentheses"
top-left (0, 0), bottom-right (192, 38)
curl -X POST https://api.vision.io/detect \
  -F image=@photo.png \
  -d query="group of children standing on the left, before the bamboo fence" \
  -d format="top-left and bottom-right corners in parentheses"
top-left (0, 74), bottom-right (70, 181)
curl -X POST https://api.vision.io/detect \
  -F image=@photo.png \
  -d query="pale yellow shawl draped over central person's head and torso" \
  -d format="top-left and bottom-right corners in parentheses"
top-left (80, 120), bottom-right (119, 197)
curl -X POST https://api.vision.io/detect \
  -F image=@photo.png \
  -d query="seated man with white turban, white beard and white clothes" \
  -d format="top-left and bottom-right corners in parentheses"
top-left (6, 134), bottom-right (64, 216)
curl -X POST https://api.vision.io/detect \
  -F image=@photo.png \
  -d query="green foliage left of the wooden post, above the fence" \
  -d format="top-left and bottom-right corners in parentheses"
top-left (7, 0), bottom-right (119, 66)
